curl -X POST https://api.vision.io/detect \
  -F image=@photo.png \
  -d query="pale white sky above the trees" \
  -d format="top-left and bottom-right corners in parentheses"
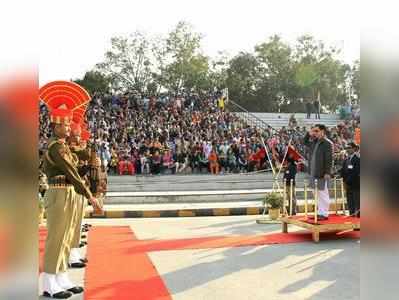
top-left (0, 0), bottom-right (360, 84)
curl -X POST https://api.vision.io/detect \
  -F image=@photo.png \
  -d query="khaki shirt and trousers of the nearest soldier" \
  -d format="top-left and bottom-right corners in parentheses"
top-left (43, 137), bottom-right (92, 274)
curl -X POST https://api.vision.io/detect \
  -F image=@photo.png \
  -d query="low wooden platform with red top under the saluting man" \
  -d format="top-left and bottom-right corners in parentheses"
top-left (280, 214), bottom-right (360, 243)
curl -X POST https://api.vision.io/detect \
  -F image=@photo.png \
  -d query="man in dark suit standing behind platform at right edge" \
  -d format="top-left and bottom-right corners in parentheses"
top-left (341, 143), bottom-right (360, 218)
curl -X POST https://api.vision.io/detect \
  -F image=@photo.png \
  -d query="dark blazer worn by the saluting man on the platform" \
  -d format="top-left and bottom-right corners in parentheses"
top-left (304, 133), bottom-right (333, 178)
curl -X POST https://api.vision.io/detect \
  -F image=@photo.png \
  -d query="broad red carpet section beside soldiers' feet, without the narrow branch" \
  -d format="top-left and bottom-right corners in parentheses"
top-left (84, 226), bottom-right (172, 300)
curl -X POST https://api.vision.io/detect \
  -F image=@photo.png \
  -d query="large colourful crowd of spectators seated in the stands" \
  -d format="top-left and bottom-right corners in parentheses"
top-left (39, 93), bottom-right (360, 175)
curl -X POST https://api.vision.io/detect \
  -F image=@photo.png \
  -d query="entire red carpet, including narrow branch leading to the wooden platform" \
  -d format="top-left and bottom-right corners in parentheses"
top-left (39, 224), bottom-right (360, 300)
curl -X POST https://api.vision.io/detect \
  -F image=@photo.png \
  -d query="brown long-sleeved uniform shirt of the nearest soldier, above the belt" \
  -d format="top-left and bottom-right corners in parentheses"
top-left (43, 137), bottom-right (92, 199)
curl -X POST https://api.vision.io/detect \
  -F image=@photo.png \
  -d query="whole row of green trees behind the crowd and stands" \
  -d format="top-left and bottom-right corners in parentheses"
top-left (82, 22), bottom-right (360, 112)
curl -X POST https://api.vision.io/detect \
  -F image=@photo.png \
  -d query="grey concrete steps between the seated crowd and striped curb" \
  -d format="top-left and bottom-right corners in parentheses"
top-left (104, 173), bottom-right (341, 205)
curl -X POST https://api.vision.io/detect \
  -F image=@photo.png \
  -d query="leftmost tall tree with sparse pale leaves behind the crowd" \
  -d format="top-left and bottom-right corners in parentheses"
top-left (97, 31), bottom-right (156, 92)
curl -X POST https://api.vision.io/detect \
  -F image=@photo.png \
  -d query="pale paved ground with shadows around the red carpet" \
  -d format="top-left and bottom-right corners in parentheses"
top-left (39, 216), bottom-right (360, 300)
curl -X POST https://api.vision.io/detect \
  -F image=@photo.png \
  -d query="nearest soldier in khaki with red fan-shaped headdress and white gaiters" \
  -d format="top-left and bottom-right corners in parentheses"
top-left (40, 81), bottom-right (101, 299)
